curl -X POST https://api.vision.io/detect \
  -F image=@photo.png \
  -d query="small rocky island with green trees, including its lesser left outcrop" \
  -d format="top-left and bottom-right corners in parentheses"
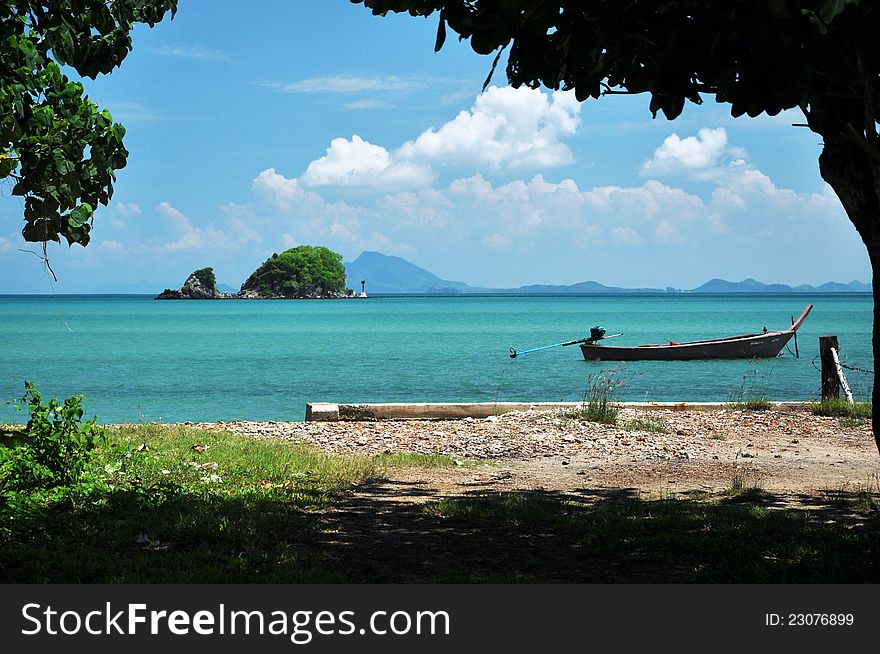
top-left (156, 245), bottom-right (356, 300)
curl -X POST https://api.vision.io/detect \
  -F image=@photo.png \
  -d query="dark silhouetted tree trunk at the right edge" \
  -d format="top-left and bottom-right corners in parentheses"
top-left (808, 113), bottom-right (880, 451)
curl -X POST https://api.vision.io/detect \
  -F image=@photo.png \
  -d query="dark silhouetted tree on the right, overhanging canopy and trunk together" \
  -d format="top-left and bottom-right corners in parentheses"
top-left (351, 0), bottom-right (880, 449)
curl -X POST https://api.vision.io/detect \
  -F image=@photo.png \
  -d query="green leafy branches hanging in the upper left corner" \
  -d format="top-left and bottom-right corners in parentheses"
top-left (0, 0), bottom-right (177, 250)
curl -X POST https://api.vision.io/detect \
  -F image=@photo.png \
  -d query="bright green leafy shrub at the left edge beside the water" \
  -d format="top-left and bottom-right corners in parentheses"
top-left (0, 382), bottom-right (103, 491)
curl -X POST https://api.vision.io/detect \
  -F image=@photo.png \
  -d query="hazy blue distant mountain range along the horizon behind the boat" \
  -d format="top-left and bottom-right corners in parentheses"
top-left (345, 252), bottom-right (871, 294)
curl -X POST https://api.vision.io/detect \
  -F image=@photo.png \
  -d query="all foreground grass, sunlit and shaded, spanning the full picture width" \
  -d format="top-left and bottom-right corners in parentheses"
top-left (0, 425), bottom-right (880, 583)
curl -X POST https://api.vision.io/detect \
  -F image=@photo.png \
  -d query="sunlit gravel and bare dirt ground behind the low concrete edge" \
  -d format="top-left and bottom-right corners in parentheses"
top-left (194, 408), bottom-right (880, 494)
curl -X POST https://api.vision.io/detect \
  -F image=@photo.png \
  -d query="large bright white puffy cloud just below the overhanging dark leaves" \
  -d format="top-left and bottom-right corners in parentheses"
top-left (394, 86), bottom-right (580, 171)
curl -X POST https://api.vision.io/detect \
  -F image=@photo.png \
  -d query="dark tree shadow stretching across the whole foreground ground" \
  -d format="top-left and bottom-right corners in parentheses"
top-left (0, 480), bottom-right (880, 583)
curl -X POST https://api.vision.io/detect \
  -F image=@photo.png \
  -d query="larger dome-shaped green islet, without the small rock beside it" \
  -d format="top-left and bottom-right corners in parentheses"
top-left (241, 245), bottom-right (347, 298)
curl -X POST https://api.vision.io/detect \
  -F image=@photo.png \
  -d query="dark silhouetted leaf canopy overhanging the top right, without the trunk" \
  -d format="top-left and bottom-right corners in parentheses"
top-left (351, 0), bottom-right (880, 119)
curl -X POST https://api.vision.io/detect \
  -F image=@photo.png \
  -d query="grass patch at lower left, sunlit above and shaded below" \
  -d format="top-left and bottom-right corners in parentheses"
top-left (0, 425), bottom-right (380, 583)
